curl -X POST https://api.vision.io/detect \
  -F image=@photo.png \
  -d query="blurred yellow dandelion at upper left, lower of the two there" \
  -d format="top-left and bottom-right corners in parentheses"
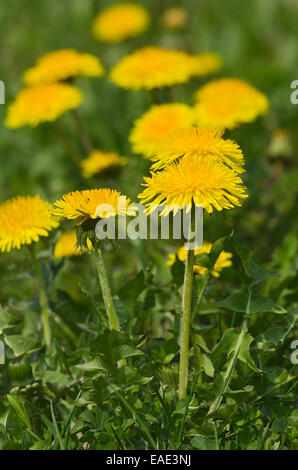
top-left (5, 83), bottom-right (82, 129)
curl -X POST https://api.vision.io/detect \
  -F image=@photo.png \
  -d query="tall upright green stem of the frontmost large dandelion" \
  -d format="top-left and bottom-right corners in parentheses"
top-left (178, 244), bottom-right (194, 399)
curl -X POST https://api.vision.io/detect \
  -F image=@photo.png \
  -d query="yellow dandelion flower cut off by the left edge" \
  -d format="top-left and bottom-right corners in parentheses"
top-left (0, 196), bottom-right (58, 253)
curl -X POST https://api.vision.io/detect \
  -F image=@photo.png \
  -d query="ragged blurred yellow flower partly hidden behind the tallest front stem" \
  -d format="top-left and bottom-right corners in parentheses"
top-left (167, 242), bottom-right (233, 277)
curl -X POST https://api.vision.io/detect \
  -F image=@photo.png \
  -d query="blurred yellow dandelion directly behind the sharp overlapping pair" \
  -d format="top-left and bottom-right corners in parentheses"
top-left (129, 103), bottom-right (193, 158)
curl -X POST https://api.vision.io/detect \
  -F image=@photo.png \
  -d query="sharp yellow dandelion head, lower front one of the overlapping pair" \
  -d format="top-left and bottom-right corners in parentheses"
top-left (138, 157), bottom-right (247, 215)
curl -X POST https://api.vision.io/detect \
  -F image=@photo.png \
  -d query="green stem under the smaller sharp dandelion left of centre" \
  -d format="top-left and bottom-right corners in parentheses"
top-left (94, 247), bottom-right (120, 331)
